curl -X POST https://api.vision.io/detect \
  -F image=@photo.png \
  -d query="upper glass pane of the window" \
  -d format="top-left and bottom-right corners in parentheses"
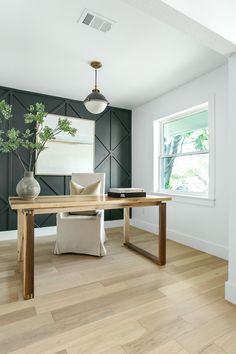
top-left (163, 111), bottom-right (208, 155)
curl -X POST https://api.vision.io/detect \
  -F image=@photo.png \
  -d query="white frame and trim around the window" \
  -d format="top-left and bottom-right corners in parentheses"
top-left (153, 96), bottom-right (215, 206)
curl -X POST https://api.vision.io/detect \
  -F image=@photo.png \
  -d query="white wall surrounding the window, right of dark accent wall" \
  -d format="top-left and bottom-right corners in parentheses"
top-left (132, 65), bottom-right (228, 258)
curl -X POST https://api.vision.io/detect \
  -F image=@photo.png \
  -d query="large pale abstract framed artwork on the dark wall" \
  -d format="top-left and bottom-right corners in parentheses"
top-left (35, 114), bottom-right (95, 176)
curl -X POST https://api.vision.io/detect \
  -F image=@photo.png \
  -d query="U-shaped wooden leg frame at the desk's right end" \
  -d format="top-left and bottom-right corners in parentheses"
top-left (124, 203), bottom-right (166, 265)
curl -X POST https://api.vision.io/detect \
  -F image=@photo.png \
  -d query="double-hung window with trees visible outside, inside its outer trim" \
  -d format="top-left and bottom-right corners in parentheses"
top-left (154, 103), bottom-right (212, 197)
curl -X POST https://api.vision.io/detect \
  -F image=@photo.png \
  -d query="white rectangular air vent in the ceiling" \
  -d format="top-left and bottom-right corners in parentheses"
top-left (78, 9), bottom-right (115, 33)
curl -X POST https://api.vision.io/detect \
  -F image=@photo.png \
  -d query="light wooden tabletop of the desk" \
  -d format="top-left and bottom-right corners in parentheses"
top-left (9, 195), bottom-right (171, 213)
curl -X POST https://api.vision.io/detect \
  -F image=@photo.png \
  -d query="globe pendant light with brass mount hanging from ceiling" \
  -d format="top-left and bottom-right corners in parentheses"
top-left (84, 61), bottom-right (109, 114)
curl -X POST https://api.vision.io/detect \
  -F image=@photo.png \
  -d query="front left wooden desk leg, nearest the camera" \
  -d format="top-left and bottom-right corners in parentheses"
top-left (23, 210), bottom-right (34, 300)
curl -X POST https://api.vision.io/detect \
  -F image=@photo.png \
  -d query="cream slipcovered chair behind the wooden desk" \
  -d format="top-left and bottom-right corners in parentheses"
top-left (54, 173), bottom-right (106, 256)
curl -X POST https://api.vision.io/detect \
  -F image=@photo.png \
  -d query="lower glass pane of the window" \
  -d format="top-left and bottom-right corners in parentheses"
top-left (161, 154), bottom-right (208, 193)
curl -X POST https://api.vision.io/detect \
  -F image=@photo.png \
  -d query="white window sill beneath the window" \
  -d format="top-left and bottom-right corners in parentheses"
top-left (153, 191), bottom-right (215, 207)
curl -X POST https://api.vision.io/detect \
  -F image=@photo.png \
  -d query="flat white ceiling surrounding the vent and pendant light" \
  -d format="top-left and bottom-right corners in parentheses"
top-left (0, 0), bottom-right (226, 108)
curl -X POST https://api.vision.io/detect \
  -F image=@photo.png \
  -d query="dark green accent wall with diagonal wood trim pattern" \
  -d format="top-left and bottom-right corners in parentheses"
top-left (0, 87), bottom-right (131, 231)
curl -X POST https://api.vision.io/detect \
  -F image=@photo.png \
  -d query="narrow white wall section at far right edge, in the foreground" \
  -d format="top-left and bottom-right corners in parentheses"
top-left (225, 54), bottom-right (236, 304)
